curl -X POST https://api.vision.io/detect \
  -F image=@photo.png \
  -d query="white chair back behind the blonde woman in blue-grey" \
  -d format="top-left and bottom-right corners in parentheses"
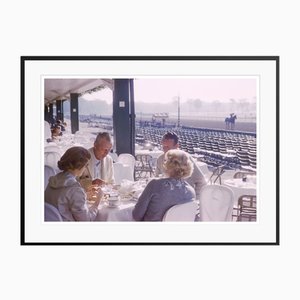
top-left (162, 201), bottom-right (198, 222)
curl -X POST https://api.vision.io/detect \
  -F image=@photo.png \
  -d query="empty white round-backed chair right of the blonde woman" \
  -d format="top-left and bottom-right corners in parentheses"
top-left (199, 184), bottom-right (234, 222)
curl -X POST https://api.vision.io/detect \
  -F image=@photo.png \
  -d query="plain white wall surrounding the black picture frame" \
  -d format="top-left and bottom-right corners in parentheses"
top-left (0, 0), bottom-right (300, 299)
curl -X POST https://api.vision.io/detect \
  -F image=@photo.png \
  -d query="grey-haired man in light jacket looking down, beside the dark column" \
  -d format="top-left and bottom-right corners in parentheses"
top-left (79, 132), bottom-right (115, 189)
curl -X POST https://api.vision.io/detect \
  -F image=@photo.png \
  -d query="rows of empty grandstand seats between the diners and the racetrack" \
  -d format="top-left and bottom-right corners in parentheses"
top-left (136, 126), bottom-right (256, 169)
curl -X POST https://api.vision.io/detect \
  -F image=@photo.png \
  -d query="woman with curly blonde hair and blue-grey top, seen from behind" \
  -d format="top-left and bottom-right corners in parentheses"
top-left (132, 149), bottom-right (195, 221)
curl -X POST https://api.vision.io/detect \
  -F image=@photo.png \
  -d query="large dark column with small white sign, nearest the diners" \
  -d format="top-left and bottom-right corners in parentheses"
top-left (113, 79), bottom-right (135, 155)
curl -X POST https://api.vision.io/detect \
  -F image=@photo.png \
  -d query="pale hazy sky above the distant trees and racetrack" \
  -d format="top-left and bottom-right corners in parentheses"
top-left (83, 77), bottom-right (257, 103)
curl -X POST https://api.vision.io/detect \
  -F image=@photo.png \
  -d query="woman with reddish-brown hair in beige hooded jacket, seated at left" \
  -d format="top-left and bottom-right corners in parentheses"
top-left (45, 147), bottom-right (103, 221)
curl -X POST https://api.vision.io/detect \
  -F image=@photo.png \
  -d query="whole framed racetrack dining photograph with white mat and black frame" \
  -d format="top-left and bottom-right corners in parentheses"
top-left (21, 56), bottom-right (279, 245)
